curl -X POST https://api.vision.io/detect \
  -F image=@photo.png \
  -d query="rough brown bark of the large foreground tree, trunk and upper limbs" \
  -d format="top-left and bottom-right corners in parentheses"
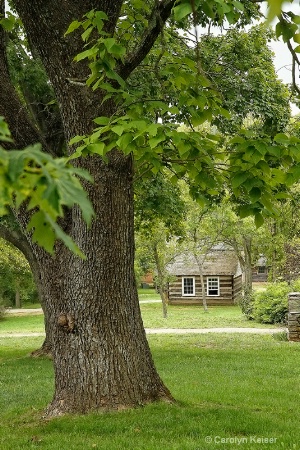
top-left (0, 0), bottom-right (174, 417)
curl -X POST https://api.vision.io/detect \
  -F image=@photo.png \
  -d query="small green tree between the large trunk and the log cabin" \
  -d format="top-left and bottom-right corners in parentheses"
top-left (135, 173), bottom-right (185, 318)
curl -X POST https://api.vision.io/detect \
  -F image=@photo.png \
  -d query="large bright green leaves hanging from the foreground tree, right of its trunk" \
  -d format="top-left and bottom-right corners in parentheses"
top-left (62, 0), bottom-right (300, 225)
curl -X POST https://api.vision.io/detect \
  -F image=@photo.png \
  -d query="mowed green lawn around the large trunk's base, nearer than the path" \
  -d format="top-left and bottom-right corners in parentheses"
top-left (0, 334), bottom-right (300, 450)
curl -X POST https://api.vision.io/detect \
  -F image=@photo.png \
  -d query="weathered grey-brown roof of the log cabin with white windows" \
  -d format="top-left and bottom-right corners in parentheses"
top-left (168, 248), bottom-right (242, 276)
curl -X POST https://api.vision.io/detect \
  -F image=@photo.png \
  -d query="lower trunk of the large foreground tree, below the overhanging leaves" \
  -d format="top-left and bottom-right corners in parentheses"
top-left (33, 156), bottom-right (171, 416)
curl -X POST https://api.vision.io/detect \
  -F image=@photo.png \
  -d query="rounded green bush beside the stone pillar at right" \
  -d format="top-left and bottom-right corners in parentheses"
top-left (252, 282), bottom-right (290, 323)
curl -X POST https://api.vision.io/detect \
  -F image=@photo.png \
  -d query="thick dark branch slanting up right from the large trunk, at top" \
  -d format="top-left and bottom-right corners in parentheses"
top-left (117, 0), bottom-right (175, 79)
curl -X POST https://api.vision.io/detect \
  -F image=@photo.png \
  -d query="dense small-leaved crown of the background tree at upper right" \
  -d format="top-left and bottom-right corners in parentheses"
top-left (200, 25), bottom-right (290, 135)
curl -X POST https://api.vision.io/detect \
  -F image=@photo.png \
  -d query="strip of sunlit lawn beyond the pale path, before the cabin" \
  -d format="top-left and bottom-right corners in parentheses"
top-left (0, 303), bottom-right (282, 334)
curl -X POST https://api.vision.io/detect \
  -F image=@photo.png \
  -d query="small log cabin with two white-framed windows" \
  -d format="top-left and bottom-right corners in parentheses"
top-left (168, 246), bottom-right (242, 306)
